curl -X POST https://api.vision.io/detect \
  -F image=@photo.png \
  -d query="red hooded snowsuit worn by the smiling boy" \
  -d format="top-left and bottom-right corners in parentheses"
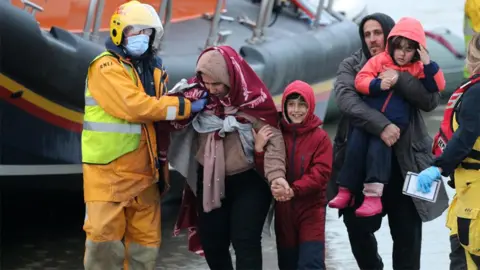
top-left (255, 81), bottom-right (333, 247)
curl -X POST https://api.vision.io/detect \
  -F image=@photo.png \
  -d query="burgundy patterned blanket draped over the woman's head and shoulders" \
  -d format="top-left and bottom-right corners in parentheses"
top-left (157, 46), bottom-right (279, 255)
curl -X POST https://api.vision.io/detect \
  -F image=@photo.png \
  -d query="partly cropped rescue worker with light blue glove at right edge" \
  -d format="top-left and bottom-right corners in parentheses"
top-left (417, 34), bottom-right (480, 270)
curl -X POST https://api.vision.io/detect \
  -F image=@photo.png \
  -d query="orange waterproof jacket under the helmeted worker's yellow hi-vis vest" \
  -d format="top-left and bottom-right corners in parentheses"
top-left (83, 51), bottom-right (191, 202)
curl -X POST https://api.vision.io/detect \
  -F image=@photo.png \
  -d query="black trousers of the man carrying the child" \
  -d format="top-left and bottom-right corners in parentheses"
top-left (341, 159), bottom-right (422, 270)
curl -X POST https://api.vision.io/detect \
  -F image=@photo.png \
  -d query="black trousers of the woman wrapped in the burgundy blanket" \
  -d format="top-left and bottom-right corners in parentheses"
top-left (197, 169), bottom-right (272, 270)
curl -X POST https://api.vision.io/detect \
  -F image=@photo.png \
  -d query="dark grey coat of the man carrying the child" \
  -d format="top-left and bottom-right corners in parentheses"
top-left (327, 50), bottom-right (448, 221)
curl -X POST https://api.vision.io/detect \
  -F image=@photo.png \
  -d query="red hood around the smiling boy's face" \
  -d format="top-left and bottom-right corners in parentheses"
top-left (281, 80), bottom-right (323, 133)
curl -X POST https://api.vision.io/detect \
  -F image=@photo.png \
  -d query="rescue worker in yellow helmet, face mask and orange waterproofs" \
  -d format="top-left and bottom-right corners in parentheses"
top-left (82, 1), bottom-right (206, 270)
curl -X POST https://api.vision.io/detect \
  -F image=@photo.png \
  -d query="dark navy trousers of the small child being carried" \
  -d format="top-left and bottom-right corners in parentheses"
top-left (337, 128), bottom-right (393, 191)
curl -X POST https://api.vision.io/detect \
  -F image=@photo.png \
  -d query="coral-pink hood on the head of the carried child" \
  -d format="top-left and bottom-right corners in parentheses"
top-left (386, 17), bottom-right (427, 51)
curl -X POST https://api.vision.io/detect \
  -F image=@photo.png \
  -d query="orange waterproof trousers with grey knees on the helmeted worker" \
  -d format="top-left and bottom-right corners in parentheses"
top-left (83, 185), bottom-right (161, 270)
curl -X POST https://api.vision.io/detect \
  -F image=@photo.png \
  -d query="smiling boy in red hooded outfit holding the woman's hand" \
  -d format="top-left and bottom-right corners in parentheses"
top-left (254, 81), bottom-right (332, 270)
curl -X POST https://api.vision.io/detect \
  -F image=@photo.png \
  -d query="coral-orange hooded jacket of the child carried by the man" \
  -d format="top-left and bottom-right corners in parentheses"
top-left (355, 17), bottom-right (446, 95)
